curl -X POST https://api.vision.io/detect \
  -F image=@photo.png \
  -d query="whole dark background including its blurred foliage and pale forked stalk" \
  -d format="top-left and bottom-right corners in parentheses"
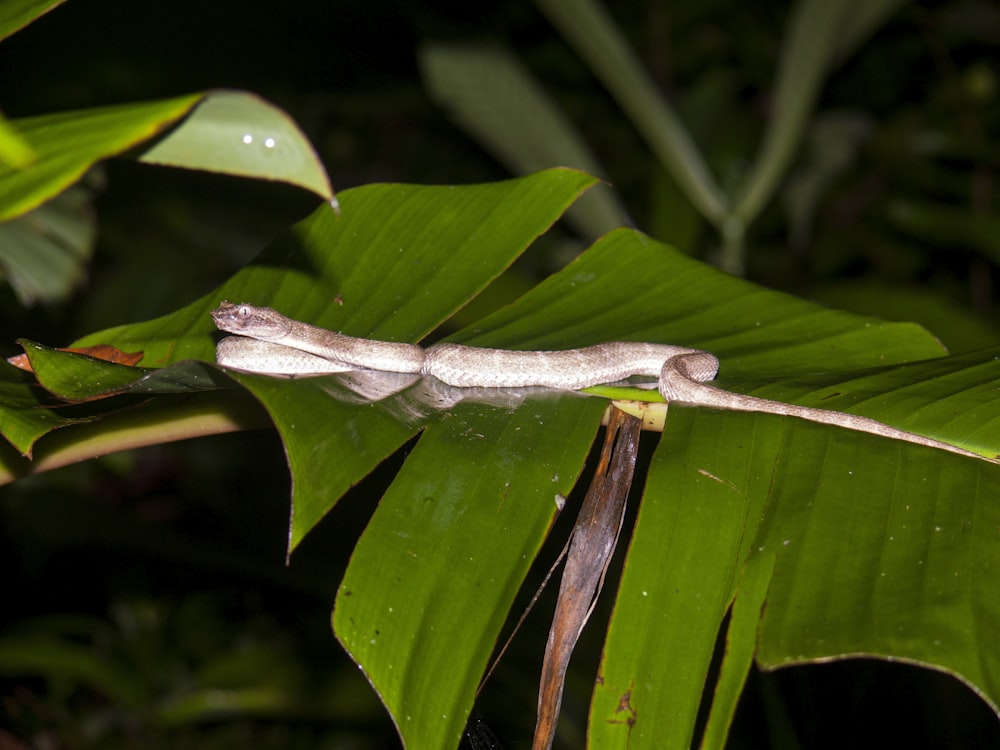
top-left (0, 0), bottom-right (1000, 747)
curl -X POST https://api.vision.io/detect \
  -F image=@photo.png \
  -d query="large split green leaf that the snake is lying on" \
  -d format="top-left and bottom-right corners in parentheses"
top-left (5, 170), bottom-right (1000, 748)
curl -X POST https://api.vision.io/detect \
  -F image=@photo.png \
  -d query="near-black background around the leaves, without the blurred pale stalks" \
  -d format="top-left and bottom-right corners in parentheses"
top-left (0, 0), bottom-right (1000, 750)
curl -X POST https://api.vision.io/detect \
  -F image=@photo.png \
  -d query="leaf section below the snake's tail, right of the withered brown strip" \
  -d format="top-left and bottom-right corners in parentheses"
top-left (590, 409), bottom-right (998, 748)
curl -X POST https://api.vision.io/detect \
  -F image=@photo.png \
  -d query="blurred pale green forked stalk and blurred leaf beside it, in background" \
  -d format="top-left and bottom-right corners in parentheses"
top-left (423, 0), bottom-right (903, 275)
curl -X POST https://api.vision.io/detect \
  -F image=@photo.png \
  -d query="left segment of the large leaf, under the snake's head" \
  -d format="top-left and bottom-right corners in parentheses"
top-left (78, 169), bottom-right (595, 551)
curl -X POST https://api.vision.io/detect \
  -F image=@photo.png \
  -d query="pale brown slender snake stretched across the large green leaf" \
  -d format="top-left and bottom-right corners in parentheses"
top-left (211, 301), bottom-right (986, 459)
